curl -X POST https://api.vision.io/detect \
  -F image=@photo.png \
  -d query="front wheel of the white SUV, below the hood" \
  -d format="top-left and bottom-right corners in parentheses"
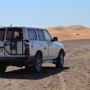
top-left (55, 51), bottom-right (64, 68)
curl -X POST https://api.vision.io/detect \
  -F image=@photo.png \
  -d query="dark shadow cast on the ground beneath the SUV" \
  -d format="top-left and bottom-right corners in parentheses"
top-left (0, 67), bottom-right (70, 80)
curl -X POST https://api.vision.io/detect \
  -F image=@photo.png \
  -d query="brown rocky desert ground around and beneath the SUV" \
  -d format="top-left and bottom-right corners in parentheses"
top-left (0, 40), bottom-right (90, 90)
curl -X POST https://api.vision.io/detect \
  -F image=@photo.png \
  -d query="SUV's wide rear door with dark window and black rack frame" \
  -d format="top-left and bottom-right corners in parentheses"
top-left (4, 28), bottom-right (23, 57)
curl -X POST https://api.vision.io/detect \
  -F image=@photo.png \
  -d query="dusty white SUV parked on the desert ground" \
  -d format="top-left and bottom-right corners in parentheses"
top-left (0, 27), bottom-right (65, 73)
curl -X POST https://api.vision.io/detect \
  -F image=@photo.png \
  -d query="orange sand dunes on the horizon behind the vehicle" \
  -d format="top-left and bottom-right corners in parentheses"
top-left (46, 25), bottom-right (90, 41)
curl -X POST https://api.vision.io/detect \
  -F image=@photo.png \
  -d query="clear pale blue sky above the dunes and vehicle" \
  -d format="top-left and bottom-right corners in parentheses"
top-left (0, 0), bottom-right (90, 27)
